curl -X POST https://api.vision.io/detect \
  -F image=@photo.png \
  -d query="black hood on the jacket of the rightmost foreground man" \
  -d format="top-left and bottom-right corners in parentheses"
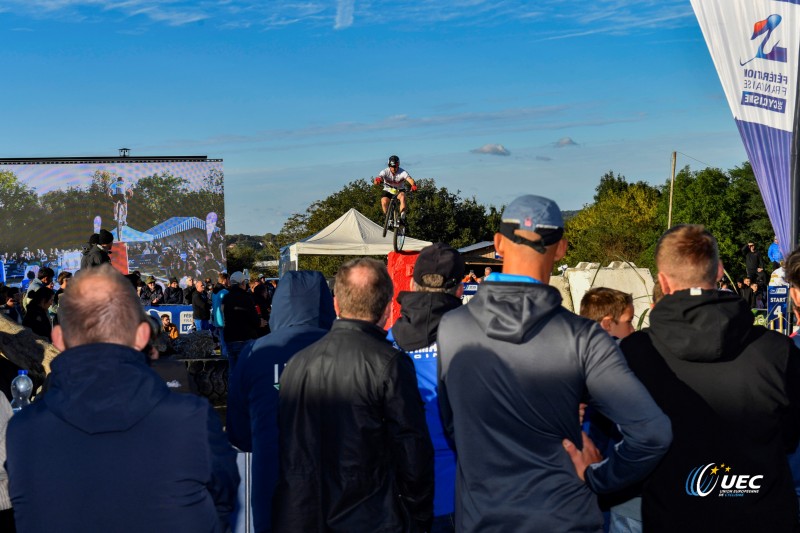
top-left (648, 289), bottom-right (753, 362)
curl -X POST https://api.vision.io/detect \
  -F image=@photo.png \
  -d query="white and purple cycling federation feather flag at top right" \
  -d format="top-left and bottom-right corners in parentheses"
top-left (691, 0), bottom-right (800, 257)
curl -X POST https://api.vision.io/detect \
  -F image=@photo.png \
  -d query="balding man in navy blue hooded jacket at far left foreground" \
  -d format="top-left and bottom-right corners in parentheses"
top-left (6, 265), bottom-right (239, 533)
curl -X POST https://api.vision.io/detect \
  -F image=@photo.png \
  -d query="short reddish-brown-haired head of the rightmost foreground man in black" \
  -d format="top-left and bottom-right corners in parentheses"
top-left (656, 224), bottom-right (720, 293)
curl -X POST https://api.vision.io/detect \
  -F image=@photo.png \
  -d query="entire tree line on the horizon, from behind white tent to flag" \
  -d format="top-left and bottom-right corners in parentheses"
top-left (233, 162), bottom-right (773, 277)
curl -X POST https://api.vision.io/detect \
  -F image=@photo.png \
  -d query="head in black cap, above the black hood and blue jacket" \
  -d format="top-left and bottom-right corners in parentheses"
top-left (414, 242), bottom-right (464, 296)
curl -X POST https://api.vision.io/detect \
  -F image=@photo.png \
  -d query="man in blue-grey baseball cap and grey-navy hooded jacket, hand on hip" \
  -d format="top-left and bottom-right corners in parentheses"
top-left (438, 195), bottom-right (672, 532)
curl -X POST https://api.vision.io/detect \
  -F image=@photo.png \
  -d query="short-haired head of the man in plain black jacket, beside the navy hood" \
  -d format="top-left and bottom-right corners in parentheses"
top-left (335, 257), bottom-right (394, 324)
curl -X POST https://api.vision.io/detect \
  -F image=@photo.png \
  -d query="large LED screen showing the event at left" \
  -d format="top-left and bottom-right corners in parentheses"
top-left (0, 157), bottom-right (225, 285)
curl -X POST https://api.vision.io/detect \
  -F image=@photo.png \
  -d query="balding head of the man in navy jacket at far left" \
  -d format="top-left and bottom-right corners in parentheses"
top-left (58, 264), bottom-right (145, 348)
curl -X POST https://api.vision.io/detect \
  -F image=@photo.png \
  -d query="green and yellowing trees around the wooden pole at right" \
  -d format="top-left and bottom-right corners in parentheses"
top-left (564, 162), bottom-right (774, 277)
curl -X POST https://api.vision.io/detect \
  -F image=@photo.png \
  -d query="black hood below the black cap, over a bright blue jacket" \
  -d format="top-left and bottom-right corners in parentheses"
top-left (392, 292), bottom-right (461, 352)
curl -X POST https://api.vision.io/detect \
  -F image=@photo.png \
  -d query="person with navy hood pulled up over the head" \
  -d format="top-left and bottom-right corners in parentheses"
top-left (227, 271), bottom-right (336, 533)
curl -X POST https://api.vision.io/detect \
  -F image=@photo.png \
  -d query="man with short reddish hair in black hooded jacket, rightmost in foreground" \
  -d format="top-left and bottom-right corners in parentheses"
top-left (621, 225), bottom-right (800, 532)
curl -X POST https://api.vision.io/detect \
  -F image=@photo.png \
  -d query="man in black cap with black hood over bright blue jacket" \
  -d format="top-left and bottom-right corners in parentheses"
top-left (389, 242), bottom-right (464, 533)
